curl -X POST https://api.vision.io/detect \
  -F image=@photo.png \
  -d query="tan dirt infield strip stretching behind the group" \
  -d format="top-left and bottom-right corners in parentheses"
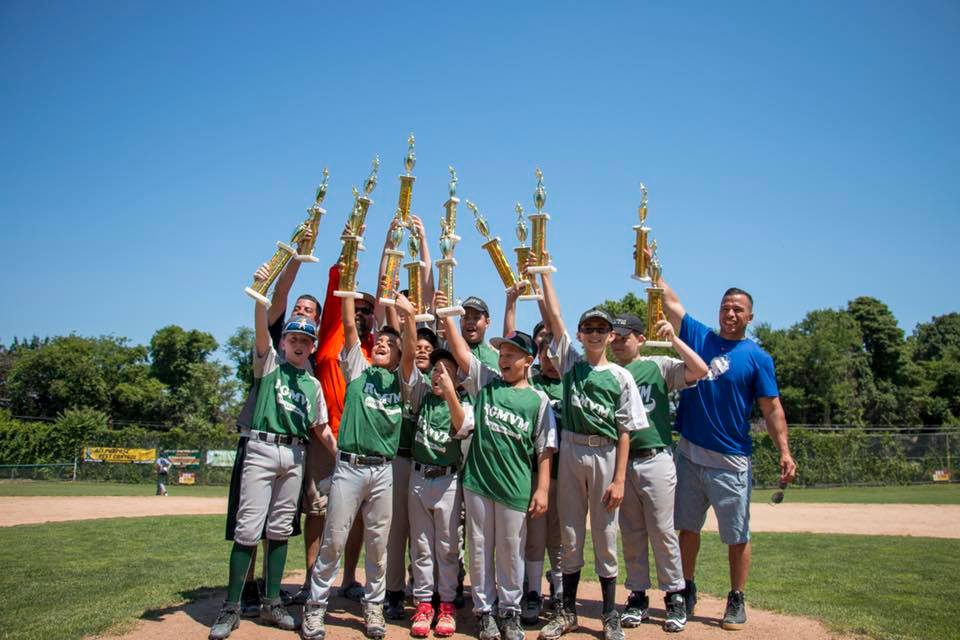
top-left (7, 496), bottom-right (960, 538)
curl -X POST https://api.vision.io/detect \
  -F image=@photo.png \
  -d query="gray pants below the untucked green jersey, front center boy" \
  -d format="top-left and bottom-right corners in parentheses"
top-left (463, 489), bottom-right (527, 615)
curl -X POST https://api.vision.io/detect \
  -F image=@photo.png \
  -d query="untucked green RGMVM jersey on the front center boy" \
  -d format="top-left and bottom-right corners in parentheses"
top-left (460, 357), bottom-right (557, 512)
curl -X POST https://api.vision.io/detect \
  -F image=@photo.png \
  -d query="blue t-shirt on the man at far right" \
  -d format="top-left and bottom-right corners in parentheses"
top-left (676, 314), bottom-right (780, 456)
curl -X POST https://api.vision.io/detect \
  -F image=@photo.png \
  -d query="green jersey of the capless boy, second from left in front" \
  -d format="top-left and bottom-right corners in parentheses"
top-left (337, 342), bottom-right (403, 457)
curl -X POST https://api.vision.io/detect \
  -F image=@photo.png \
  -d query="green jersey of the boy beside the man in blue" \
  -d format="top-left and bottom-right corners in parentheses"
top-left (624, 356), bottom-right (696, 449)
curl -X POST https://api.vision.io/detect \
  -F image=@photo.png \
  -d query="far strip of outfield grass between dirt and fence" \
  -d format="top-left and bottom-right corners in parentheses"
top-left (0, 480), bottom-right (960, 504)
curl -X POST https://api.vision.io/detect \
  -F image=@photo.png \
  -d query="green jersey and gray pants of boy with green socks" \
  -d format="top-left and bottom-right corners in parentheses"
top-left (233, 345), bottom-right (327, 546)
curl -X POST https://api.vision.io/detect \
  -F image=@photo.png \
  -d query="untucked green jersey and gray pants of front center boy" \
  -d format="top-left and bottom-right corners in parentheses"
top-left (461, 357), bottom-right (557, 614)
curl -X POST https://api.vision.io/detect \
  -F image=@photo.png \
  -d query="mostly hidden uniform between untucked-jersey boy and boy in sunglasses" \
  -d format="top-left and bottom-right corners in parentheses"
top-left (523, 373), bottom-right (563, 593)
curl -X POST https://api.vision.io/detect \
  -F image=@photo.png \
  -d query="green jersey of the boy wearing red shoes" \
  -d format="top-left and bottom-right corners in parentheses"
top-left (403, 369), bottom-right (473, 467)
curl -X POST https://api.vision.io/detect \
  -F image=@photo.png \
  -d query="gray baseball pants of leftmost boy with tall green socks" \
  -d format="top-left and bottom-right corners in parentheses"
top-left (233, 438), bottom-right (304, 547)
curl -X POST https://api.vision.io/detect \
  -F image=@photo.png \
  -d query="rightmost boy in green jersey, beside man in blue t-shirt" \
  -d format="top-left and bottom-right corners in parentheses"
top-left (610, 314), bottom-right (707, 631)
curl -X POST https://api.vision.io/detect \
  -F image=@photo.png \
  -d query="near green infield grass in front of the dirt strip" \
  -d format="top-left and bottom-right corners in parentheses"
top-left (0, 516), bottom-right (960, 640)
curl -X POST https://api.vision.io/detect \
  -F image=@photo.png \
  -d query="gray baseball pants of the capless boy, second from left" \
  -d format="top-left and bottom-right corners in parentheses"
top-left (308, 458), bottom-right (393, 606)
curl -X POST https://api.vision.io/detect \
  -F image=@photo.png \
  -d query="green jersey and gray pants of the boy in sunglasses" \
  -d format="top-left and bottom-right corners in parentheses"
top-left (550, 333), bottom-right (649, 578)
